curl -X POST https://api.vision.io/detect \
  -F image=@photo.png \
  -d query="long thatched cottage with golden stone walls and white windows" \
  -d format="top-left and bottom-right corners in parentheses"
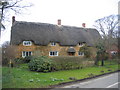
top-left (11, 17), bottom-right (100, 57)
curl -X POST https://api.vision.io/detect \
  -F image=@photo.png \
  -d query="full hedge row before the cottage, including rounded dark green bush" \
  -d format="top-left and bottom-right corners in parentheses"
top-left (28, 56), bottom-right (94, 72)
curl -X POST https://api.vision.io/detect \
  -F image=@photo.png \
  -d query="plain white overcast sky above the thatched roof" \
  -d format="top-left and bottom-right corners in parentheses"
top-left (0, 0), bottom-right (120, 44)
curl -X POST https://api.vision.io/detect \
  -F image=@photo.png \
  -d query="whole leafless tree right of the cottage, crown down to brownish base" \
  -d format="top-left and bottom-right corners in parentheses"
top-left (94, 15), bottom-right (118, 58)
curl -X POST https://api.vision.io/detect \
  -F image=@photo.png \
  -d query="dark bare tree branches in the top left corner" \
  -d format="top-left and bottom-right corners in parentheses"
top-left (0, 0), bottom-right (32, 37)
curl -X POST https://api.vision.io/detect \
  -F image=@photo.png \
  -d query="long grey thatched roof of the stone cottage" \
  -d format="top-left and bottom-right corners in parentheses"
top-left (11, 21), bottom-right (101, 46)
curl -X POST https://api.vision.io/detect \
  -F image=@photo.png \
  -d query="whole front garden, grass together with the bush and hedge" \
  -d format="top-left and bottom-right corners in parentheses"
top-left (2, 56), bottom-right (119, 88)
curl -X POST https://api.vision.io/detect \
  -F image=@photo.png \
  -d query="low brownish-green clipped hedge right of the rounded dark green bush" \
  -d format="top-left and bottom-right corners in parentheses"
top-left (52, 57), bottom-right (94, 71)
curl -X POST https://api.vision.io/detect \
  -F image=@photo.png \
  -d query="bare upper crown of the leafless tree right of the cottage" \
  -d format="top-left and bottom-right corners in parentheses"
top-left (94, 15), bottom-right (118, 38)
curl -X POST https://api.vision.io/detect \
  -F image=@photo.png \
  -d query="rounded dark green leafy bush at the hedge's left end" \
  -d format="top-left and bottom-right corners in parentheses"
top-left (28, 56), bottom-right (53, 72)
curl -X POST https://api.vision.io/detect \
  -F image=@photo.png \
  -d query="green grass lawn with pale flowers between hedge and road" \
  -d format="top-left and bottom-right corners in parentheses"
top-left (2, 62), bottom-right (118, 88)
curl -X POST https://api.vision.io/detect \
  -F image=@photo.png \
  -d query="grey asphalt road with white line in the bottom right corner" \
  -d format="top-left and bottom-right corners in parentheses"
top-left (62, 72), bottom-right (120, 88)
